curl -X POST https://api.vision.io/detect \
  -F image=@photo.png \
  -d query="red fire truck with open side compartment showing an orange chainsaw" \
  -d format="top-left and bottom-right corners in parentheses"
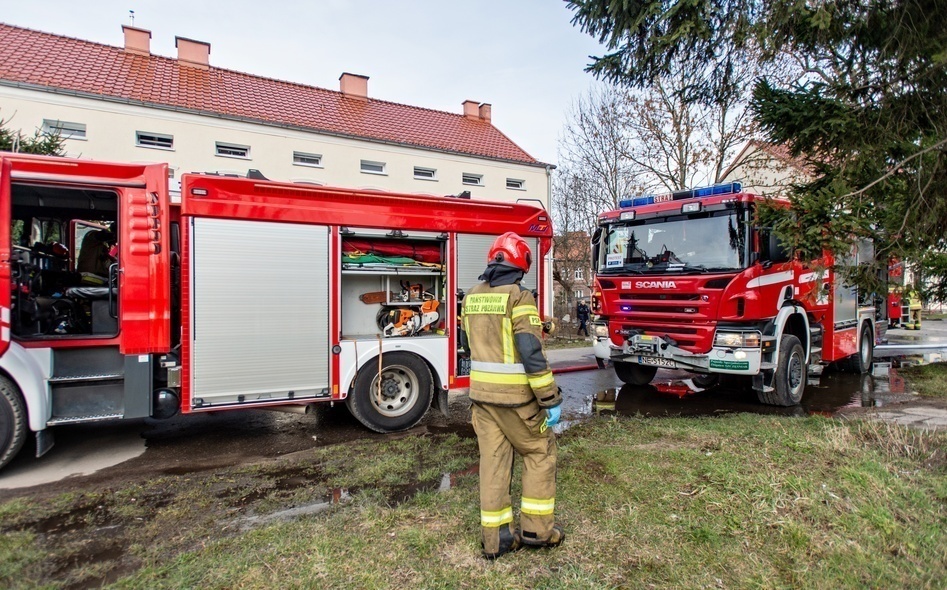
top-left (0, 154), bottom-right (552, 466)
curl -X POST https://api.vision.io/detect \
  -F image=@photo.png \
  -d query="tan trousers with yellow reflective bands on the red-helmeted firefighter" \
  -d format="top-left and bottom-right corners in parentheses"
top-left (472, 402), bottom-right (556, 553)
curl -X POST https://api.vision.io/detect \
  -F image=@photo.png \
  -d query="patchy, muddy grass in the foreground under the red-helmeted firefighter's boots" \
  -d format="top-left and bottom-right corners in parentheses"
top-left (0, 414), bottom-right (947, 590)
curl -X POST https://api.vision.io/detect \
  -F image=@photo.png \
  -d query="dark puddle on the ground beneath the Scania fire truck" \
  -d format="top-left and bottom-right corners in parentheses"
top-left (592, 365), bottom-right (913, 420)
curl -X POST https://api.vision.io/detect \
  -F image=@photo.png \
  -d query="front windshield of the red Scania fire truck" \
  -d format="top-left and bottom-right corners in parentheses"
top-left (597, 209), bottom-right (748, 274)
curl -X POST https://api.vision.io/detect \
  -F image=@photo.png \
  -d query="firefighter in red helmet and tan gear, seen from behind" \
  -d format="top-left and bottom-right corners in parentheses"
top-left (462, 232), bottom-right (565, 559)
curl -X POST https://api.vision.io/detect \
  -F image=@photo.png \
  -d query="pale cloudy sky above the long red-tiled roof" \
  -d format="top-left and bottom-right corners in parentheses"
top-left (0, 0), bottom-right (604, 164)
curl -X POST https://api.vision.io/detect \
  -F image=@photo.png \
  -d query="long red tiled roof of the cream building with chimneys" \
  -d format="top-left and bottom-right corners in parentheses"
top-left (0, 23), bottom-right (539, 165)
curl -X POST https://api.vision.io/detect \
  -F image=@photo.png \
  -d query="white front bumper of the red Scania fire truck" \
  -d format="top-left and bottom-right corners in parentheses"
top-left (593, 334), bottom-right (762, 375)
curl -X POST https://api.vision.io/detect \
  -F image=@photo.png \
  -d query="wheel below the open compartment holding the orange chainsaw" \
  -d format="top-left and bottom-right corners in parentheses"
top-left (345, 352), bottom-right (434, 432)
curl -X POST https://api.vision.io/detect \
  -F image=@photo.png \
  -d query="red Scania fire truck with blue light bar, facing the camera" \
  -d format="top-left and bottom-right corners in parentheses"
top-left (592, 182), bottom-right (887, 406)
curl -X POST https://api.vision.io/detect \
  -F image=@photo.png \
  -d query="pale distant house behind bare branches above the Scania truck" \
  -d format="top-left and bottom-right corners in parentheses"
top-left (720, 140), bottom-right (811, 195)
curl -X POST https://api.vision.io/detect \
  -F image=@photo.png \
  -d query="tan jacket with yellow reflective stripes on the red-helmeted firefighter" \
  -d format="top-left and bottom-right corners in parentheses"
top-left (462, 283), bottom-right (562, 407)
